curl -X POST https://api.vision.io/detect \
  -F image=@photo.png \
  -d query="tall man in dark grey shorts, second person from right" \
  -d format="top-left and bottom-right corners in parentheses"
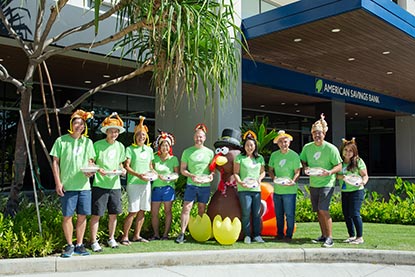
top-left (300, 114), bottom-right (342, 247)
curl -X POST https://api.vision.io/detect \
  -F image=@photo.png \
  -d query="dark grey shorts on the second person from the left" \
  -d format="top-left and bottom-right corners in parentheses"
top-left (92, 187), bottom-right (122, 216)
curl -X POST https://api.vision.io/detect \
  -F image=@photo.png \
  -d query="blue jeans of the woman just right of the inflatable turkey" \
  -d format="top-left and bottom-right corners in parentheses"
top-left (238, 191), bottom-right (261, 237)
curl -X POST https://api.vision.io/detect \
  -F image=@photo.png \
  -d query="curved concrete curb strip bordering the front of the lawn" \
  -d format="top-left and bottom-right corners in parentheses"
top-left (0, 248), bottom-right (415, 275)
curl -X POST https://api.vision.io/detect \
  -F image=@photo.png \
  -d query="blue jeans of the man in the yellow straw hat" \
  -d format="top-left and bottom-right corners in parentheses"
top-left (274, 193), bottom-right (297, 239)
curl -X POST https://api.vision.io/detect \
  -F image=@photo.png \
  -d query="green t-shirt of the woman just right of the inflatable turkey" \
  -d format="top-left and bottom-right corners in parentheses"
top-left (235, 154), bottom-right (265, 192)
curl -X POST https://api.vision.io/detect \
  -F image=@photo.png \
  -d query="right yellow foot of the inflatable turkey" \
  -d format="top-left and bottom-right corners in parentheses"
top-left (213, 215), bottom-right (242, 245)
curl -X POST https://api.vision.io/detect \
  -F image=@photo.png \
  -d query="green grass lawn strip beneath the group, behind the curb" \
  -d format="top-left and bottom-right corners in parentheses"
top-left (94, 222), bottom-right (415, 254)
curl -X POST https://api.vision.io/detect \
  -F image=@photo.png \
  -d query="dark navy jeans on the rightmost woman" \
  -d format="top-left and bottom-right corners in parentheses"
top-left (342, 190), bottom-right (365, 237)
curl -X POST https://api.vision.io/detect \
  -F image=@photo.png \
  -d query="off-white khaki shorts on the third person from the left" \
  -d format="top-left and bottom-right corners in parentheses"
top-left (126, 182), bottom-right (151, 213)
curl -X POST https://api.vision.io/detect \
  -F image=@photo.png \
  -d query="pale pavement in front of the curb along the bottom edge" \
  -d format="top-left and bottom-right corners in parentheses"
top-left (6, 263), bottom-right (415, 277)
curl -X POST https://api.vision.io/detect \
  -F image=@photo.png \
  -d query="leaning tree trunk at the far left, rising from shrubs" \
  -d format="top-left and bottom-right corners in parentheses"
top-left (5, 64), bottom-right (36, 217)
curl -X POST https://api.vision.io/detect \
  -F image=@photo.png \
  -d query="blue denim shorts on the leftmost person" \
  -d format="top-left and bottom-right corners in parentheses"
top-left (60, 190), bottom-right (91, 216)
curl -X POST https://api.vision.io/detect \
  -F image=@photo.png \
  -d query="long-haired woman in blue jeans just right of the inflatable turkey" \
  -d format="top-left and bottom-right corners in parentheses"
top-left (233, 130), bottom-right (265, 243)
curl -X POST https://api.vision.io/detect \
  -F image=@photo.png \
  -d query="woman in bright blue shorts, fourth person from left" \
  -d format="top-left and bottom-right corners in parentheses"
top-left (151, 130), bottom-right (179, 240)
